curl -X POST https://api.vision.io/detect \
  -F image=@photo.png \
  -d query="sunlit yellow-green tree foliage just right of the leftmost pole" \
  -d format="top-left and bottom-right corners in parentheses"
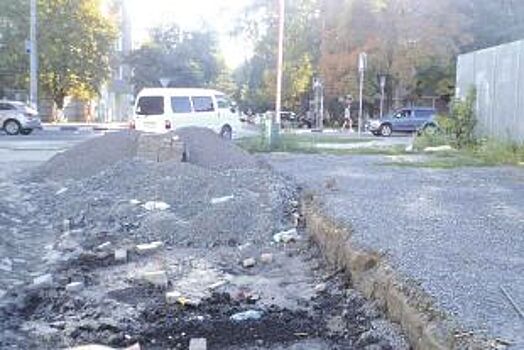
top-left (38, 0), bottom-right (116, 110)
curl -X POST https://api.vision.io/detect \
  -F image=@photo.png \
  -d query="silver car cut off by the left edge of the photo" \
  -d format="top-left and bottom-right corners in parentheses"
top-left (0, 100), bottom-right (42, 135)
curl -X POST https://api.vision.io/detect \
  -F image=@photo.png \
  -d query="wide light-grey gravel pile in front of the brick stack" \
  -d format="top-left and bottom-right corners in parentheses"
top-left (35, 160), bottom-right (294, 247)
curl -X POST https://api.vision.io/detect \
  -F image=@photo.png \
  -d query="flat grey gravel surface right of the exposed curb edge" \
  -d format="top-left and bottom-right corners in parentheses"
top-left (269, 155), bottom-right (524, 349)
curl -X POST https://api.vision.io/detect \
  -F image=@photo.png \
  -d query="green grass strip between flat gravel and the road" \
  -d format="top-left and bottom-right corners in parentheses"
top-left (236, 134), bottom-right (405, 155)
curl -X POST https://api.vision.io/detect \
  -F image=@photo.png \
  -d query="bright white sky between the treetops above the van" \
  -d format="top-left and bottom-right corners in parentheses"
top-left (127, 0), bottom-right (252, 68)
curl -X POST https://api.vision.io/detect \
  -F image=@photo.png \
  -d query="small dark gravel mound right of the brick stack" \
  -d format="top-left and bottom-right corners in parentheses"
top-left (175, 128), bottom-right (257, 170)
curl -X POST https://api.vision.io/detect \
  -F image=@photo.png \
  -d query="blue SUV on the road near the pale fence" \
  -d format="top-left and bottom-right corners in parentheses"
top-left (369, 107), bottom-right (437, 137)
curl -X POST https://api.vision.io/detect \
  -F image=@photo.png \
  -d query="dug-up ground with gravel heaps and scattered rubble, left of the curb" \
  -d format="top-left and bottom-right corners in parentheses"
top-left (0, 130), bottom-right (409, 350)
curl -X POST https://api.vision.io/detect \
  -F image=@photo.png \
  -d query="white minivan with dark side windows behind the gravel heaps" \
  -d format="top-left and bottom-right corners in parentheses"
top-left (131, 88), bottom-right (241, 139)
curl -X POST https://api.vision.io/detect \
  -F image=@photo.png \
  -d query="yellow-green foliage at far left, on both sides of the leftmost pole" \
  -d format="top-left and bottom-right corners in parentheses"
top-left (0, 0), bottom-right (115, 109)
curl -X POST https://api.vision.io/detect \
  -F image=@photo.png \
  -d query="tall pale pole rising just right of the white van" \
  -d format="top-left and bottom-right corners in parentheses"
top-left (268, 0), bottom-right (286, 146)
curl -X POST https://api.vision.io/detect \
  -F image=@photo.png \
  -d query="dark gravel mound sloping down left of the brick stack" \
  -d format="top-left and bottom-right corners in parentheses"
top-left (33, 131), bottom-right (139, 181)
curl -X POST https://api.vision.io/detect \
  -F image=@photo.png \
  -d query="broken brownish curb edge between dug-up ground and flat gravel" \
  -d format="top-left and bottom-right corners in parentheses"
top-left (302, 194), bottom-right (500, 350)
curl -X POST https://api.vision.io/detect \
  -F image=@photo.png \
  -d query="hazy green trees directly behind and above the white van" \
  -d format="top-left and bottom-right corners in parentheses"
top-left (126, 24), bottom-right (223, 92)
